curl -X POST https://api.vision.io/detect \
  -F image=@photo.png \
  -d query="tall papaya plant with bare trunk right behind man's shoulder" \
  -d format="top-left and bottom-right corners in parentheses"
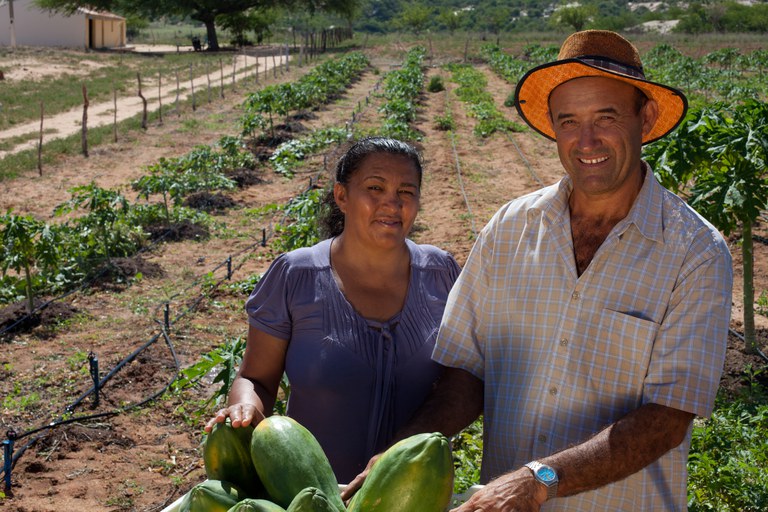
top-left (645, 100), bottom-right (768, 354)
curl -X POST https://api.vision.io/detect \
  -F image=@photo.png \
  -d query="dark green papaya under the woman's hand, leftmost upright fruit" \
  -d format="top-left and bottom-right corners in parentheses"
top-left (203, 418), bottom-right (266, 498)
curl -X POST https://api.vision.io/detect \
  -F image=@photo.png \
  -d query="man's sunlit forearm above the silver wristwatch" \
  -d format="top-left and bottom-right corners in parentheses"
top-left (541, 404), bottom-right (694, 496)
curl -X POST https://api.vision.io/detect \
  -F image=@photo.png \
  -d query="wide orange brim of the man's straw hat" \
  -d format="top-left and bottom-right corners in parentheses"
top-left (515, 59), bottom-right (688, 144)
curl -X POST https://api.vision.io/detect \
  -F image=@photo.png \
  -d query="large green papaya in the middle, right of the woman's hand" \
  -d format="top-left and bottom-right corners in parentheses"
top-left (251, 416), bottom-right (346, 512)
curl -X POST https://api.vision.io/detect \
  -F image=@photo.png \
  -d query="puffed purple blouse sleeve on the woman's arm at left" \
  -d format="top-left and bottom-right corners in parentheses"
top-left (245, 255), bottom-right (291, 340)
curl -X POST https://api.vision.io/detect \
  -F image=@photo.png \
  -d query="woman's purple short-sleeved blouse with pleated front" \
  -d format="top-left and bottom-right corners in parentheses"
top-left (246, 239), bottom-right (460, 483)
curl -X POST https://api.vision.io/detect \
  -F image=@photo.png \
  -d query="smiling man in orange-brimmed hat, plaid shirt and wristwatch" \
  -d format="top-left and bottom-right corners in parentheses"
top-left (402, 30), bottom-right (733, 512)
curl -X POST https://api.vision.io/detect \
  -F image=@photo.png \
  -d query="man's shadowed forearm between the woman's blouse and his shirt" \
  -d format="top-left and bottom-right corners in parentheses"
top-left (395, 368), bottom-right (483, 440)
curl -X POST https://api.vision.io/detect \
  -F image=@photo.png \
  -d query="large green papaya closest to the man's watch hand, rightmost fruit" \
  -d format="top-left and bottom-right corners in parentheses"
top-left (347, 432), bottom-right (453, 512)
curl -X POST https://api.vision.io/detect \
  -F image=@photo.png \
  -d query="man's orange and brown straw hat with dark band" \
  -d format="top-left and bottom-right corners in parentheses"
top-left (515, 30), bottom-right (688, 144)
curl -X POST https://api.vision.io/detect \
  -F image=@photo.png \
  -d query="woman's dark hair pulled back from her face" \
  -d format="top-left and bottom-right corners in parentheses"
top-left (318, 137), bottom-right (423, 239)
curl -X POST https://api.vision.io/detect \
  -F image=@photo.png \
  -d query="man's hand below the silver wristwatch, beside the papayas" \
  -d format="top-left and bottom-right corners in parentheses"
top-left (451, 468), bottom-right (547, 512)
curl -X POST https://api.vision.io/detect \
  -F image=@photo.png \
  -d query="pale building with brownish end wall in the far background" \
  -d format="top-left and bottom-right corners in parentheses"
top-left (0, 0), bottom-right (126, 49)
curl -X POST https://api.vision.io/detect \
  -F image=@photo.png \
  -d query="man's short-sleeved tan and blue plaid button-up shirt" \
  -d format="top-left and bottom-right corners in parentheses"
top-left (433, 164), bottom-right (733, 512)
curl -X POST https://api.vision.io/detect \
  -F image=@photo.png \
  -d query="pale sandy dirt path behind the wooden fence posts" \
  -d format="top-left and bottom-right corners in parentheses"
top-left (0, 53), bottom-right (285, 159)
